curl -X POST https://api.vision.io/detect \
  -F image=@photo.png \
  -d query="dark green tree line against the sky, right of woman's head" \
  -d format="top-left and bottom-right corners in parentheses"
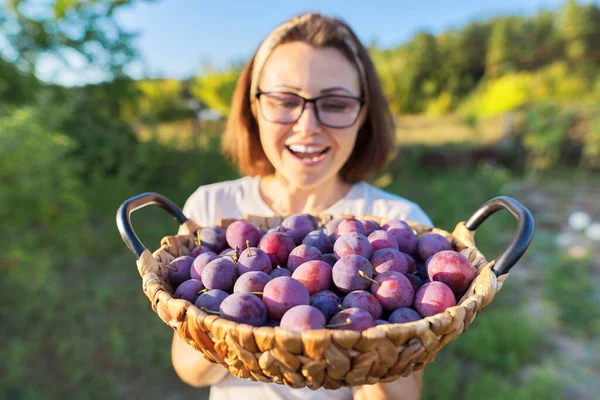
top-left (369, 0), bottom-right (600, 113)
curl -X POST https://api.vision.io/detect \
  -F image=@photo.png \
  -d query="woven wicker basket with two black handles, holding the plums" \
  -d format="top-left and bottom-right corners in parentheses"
top-left (117, 193), bottom-right (534, 389)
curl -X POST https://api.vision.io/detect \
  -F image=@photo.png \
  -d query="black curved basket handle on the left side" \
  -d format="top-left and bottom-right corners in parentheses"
top-left (117, 193), bottom-right (187, 258)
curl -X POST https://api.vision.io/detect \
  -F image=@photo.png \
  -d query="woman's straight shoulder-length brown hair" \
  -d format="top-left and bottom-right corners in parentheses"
top-left (222, 13), bottom-right (396, 183)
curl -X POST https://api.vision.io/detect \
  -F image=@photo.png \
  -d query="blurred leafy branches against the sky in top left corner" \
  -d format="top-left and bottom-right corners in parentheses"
top-left (0, 0), bottom-right (136, 79)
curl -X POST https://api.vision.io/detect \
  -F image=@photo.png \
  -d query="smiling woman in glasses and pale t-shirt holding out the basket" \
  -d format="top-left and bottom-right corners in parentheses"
top-left (172, 13), bottom-right (432, 400)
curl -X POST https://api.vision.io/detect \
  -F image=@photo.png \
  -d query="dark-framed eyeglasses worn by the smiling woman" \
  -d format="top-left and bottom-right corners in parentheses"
top-left (256, 90), bottom-right (365, 128)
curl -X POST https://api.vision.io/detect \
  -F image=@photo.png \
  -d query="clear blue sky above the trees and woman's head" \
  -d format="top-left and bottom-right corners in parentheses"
top-left (38, 0), bottom-right (596, 85)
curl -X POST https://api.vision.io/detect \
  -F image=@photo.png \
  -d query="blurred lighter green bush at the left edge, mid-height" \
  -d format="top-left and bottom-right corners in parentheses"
top-left (0, 108), bottom-right (87, 260)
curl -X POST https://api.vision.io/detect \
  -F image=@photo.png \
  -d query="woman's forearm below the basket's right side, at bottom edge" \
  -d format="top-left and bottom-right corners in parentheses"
top-left (352, 370), bottom-right (423, 400)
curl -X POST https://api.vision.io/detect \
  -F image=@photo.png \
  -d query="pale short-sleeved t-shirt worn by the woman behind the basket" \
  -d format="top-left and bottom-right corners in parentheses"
top-left (178, 176), bottom-right (433, 400)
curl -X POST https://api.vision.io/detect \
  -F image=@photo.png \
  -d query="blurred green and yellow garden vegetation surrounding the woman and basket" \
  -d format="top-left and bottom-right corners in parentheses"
top-left (0, 0), bottom-right (600, 399)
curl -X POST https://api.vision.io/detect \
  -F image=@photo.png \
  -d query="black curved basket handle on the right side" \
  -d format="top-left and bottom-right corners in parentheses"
top-left (465, 196), bottom-right (535, 276)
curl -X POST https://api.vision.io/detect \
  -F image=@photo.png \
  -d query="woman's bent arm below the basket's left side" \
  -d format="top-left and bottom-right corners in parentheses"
top-left (171, 333), bottom-right (229, 387)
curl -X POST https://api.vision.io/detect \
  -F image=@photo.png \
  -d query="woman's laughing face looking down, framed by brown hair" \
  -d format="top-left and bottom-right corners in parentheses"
top-left (255, 42), bottom-right (366, 189)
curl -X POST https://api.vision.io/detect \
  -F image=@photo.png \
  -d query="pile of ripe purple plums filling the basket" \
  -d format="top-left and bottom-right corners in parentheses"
top-left (167, 214), bottom-right (475, 331)
